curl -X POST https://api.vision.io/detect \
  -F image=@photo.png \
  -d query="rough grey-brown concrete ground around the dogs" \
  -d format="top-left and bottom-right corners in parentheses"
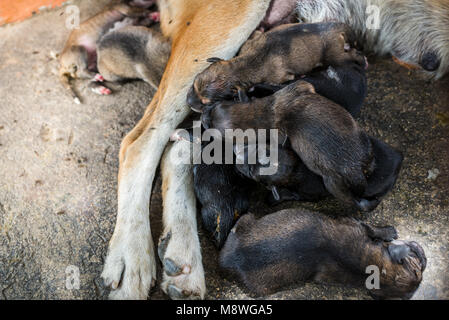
top-left (0, 0), bottom-right (449, 299)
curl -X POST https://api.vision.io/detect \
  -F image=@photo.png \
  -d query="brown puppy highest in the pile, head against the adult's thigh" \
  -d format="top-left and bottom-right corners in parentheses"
top-left (188, 23), bottom-right (365, 110)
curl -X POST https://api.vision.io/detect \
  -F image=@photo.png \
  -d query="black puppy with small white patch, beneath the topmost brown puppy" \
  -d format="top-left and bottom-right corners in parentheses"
top-left (248, 61), bottom-right (368, 118)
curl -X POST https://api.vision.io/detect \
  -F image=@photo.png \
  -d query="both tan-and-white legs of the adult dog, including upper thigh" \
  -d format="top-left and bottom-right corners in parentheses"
top-left (102, 0), bottom-right (449, 299)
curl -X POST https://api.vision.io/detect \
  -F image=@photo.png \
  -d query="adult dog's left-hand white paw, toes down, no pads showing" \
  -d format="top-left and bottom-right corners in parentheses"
top-left (101, 230), bottom-right (156, 300)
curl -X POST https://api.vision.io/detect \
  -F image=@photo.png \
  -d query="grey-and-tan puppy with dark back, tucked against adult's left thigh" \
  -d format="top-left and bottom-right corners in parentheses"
top-left (98, 26), bottom-right (171, 89)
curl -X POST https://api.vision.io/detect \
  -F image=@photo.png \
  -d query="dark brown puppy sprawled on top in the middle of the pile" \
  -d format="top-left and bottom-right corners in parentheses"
top-left (202, 80), bottom-right (398, 211)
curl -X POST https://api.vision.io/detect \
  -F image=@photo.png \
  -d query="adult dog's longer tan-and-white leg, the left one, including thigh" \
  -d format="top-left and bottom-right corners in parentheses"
top-left (102, 0), bottom-right (270, 299)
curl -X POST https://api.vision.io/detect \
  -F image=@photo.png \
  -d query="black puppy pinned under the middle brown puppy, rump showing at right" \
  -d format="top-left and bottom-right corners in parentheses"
top-left (235, 137), bottom-right (403, 211)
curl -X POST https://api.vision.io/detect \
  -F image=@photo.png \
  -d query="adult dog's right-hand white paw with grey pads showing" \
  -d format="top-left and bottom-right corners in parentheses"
top-left (158, 231), bottom-right (206, 300)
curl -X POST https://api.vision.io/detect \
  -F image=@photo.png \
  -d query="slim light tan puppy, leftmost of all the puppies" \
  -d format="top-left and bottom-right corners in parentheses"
top-left (59, 1), bottom-right (156, 103)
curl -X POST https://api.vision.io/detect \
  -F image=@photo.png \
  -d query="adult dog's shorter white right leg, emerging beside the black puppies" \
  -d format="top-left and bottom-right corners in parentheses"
top-left (158, 140), bottom-right (206, 299)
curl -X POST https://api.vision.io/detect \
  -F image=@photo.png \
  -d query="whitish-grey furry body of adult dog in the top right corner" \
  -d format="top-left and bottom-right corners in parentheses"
top-left (297, 0), bottom-right (449, 79)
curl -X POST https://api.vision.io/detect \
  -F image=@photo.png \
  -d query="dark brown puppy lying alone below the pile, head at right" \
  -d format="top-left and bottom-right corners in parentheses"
top-left (219, 209), bottom-right (427, 299)
